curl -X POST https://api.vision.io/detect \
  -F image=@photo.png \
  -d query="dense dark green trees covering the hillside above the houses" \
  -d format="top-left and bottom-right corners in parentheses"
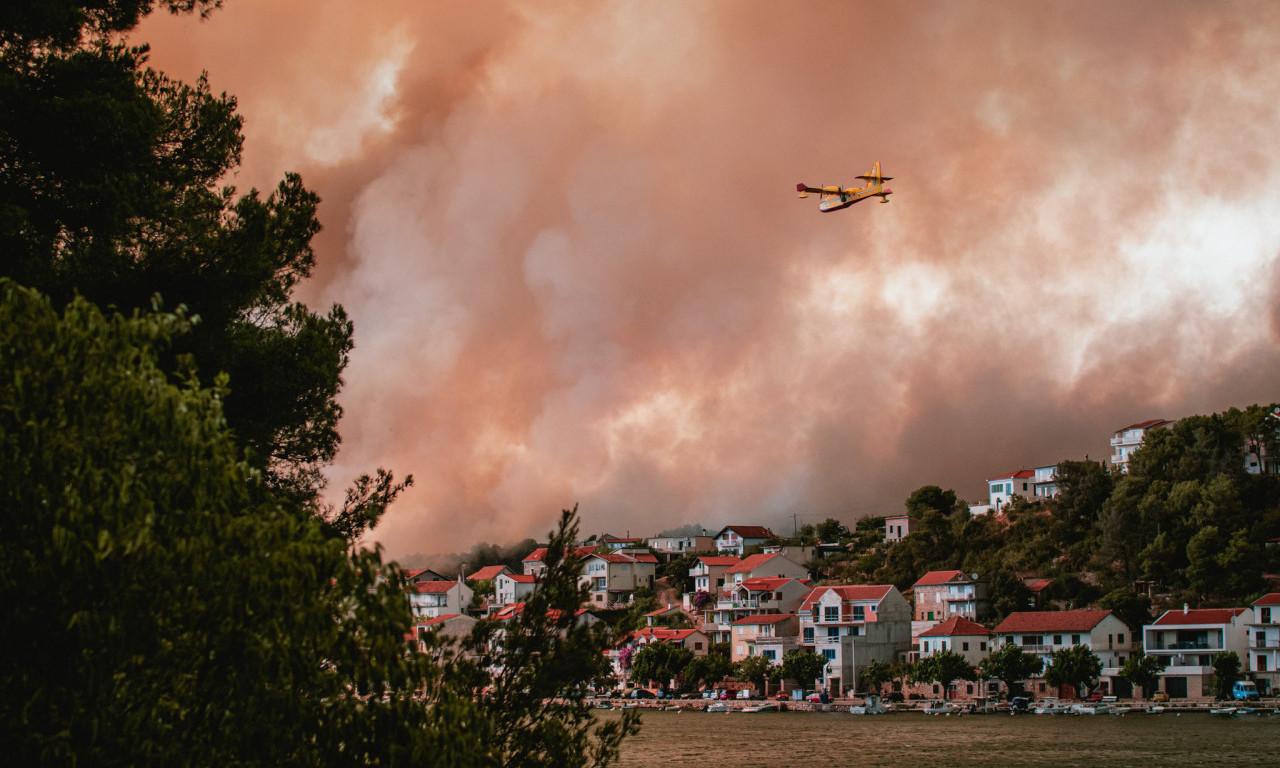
top-left (785, 404), bottom-right (1280, 620)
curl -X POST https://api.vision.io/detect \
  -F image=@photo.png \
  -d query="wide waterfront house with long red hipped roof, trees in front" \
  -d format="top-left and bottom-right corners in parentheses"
top-left (992, 611), bottom-right (1139, 695)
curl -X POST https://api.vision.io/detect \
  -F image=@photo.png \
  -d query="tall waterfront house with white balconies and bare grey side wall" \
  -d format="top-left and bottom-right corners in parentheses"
top-left (800, 585), bottom-right (911, 695)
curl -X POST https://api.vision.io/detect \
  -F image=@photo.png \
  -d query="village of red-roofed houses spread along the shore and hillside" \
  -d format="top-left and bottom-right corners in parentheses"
top-left (408, 420), bottom-right (1280, 708)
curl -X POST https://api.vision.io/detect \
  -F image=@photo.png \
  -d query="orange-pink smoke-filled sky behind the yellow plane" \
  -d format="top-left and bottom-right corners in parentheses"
top-left (133, 0), bottom-right (1280, 556)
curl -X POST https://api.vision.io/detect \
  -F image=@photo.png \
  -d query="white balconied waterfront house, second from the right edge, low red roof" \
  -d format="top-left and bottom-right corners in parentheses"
top-left (1142, 604), bottom-right (1253, 699)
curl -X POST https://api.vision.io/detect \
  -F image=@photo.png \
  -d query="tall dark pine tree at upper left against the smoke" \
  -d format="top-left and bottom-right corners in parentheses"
top-left (0, 0), bottom-right (403, 522)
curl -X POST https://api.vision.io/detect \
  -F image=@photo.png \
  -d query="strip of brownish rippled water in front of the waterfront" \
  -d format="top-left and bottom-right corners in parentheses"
top-left (600, 710), bottom-right (1280, 768)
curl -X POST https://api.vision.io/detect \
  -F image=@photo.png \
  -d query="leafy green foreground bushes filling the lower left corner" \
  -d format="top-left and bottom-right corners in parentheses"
top-left (0, 280), bottom-right (636, 767)
